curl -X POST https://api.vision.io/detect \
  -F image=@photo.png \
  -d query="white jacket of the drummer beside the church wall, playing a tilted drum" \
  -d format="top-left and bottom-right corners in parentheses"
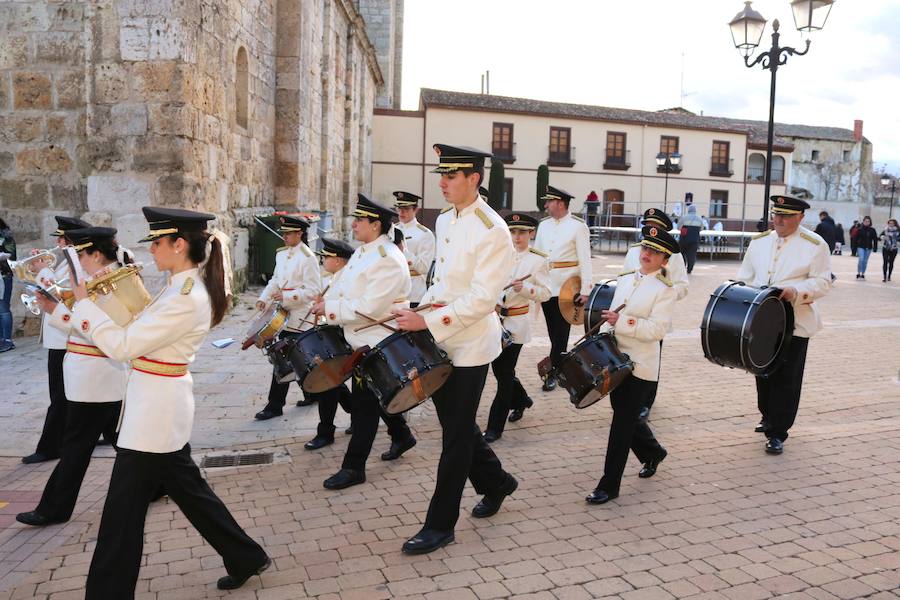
top-left (259, 242), bottom-right (322, 331)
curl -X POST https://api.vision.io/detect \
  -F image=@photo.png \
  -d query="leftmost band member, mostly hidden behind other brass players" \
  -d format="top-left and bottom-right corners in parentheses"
top-left (22, 215), bottom-right (91, 465)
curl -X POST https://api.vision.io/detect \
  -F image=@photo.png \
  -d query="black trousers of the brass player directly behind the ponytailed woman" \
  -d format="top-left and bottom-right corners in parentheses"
top-left (35, 402), bottom-right (122, 521)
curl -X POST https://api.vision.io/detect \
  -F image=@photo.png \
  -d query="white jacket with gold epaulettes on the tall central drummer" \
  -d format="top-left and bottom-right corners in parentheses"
top-left (422, 197), bottom-right (515, 367)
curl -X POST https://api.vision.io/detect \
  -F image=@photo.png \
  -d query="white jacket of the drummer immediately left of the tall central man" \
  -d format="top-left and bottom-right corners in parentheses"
top-left (325, 235), bottom-right (410, 350)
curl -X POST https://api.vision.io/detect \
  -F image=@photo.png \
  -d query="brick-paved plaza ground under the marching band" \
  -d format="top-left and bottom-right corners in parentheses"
top-left (0, 251), bottom-right (900, 600)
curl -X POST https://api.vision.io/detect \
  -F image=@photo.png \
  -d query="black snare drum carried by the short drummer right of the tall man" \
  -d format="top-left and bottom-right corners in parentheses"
top-left (556, 333), bottom-right (634, 408)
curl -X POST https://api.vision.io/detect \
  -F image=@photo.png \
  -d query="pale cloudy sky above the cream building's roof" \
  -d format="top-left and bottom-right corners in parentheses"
top-left (403, 0), bottom-right (900, 175)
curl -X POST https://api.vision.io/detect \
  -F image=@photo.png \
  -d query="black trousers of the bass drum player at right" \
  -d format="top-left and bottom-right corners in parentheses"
top-left (756, 337), bottom-right (809, 441)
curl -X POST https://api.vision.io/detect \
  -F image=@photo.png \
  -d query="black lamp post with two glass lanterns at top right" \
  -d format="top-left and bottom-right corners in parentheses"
top-left (728, 0), bottom-right (834, 223)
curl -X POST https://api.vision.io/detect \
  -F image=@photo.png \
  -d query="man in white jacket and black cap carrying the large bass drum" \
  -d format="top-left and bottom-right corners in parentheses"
top-left (737, 196), bottom-right (831, 454)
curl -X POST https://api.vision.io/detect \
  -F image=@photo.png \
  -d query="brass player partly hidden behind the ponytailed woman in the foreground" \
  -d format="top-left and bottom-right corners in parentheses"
top-left (16, 227), bottom-right (132, 527)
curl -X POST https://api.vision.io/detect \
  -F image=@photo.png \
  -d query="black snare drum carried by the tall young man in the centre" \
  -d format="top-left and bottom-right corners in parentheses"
top-left (359, 330), bottom-right (453, 415)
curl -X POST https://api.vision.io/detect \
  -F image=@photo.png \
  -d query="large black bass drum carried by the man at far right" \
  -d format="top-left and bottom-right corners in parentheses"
top-left (700, 281), bottom-right (794, 377)
